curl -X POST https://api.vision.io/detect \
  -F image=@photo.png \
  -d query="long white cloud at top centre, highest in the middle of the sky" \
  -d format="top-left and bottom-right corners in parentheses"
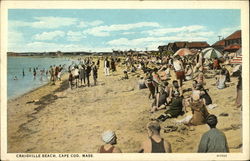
top-left (84, 22), bottom-right (160, 37)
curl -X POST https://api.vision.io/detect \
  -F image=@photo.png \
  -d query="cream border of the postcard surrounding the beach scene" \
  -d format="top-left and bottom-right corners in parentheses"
top-left (1, 1), bottom-right (249, 160)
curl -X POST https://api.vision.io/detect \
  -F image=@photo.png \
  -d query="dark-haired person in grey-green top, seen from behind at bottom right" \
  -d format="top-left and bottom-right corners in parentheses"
top-left (198, 115), bottom-right (229, 153)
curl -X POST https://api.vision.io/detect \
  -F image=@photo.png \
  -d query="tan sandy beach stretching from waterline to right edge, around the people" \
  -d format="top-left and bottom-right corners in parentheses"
top-left (7, 58), bottom-right (242, 153)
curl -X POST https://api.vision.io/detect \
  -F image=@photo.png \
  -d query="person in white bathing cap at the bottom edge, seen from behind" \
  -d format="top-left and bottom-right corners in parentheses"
top-left (98, 130), bottom-right (122, 153)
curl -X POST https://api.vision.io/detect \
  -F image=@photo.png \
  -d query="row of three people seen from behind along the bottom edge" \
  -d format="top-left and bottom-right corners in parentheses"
top-left (97, 115), bottom-right (229, 153)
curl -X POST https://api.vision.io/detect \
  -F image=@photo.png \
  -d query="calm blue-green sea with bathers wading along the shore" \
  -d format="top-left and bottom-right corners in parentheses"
top-left (7, 57), bottom-right (72, 99)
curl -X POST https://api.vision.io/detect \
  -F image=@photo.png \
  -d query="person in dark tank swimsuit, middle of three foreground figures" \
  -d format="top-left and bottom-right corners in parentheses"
top-left (139, 121), bottom-right (172, 153)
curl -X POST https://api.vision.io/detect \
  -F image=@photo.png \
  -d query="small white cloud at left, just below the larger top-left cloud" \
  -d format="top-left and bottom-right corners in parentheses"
top-left (34, 31), bottom-right (65, 40)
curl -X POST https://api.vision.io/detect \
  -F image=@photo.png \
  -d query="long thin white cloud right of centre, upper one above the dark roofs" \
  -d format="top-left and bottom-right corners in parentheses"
top-left (142, 25), bottom-right (205, 36)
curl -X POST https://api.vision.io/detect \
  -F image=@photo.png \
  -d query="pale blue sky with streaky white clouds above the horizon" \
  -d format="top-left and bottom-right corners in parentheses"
top-left (8, 9), bottom-right (241, 52)
